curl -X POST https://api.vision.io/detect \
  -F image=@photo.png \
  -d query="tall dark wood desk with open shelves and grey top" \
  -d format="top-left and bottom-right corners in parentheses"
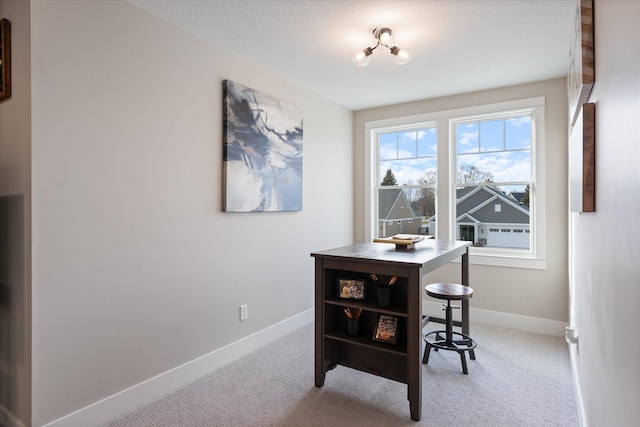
top-left (311, 240), bottom-right (469, 421)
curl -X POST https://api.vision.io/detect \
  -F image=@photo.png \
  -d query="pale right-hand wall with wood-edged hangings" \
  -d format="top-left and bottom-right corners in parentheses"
top-left (570, 0), bottom-right (640, 427)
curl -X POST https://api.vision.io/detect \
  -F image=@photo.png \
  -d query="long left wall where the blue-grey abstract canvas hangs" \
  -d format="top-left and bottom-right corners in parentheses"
top-left (31, 1), bottom-right (354, 425)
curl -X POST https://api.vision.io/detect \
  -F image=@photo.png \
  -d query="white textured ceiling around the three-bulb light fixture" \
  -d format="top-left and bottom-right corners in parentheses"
top-left (129, 0), bottom-right (576, 110)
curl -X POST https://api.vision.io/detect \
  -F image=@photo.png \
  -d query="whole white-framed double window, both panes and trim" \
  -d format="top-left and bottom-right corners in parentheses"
top-left (365, 97), bottom-right (545, 268)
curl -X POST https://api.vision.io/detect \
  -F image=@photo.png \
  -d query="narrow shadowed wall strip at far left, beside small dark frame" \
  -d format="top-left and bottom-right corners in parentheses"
top-left (0, 0), bottom-right (31, 426)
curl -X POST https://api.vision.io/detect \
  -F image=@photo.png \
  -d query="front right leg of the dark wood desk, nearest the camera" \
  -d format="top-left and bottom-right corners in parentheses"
top-left (407, 269), bottom-right (422, 421)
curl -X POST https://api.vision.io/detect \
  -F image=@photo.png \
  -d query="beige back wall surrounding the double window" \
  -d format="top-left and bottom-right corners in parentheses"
top-left (354, 78), bottom-right (568, 330)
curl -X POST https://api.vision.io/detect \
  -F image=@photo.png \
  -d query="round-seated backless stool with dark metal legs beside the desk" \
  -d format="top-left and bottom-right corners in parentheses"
top-left (422, 283), bottom-right (476, 374)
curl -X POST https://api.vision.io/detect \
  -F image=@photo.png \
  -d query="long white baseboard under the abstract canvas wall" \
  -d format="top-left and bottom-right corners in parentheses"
top-left (42, 309), bottom-right (314, 427)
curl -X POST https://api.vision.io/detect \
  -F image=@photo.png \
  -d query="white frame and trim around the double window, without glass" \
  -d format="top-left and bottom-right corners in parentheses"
top-left (364, 96), bottom-right (546, 269)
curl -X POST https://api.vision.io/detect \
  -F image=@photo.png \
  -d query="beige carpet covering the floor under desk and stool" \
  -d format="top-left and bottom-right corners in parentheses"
top-left (107, 324), bottom-right (578, 427)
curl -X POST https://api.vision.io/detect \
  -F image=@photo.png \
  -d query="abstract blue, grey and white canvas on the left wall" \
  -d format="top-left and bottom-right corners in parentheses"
top-left (223, 80), bottom-right (302, 212)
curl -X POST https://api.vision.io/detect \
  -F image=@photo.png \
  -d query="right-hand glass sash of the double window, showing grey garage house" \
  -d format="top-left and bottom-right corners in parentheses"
top-left (451, 110), bottom-right (533, 252)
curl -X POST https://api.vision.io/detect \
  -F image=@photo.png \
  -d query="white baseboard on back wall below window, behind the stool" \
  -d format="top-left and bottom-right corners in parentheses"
top-left (422, 300), bottom-right (567, 337)
